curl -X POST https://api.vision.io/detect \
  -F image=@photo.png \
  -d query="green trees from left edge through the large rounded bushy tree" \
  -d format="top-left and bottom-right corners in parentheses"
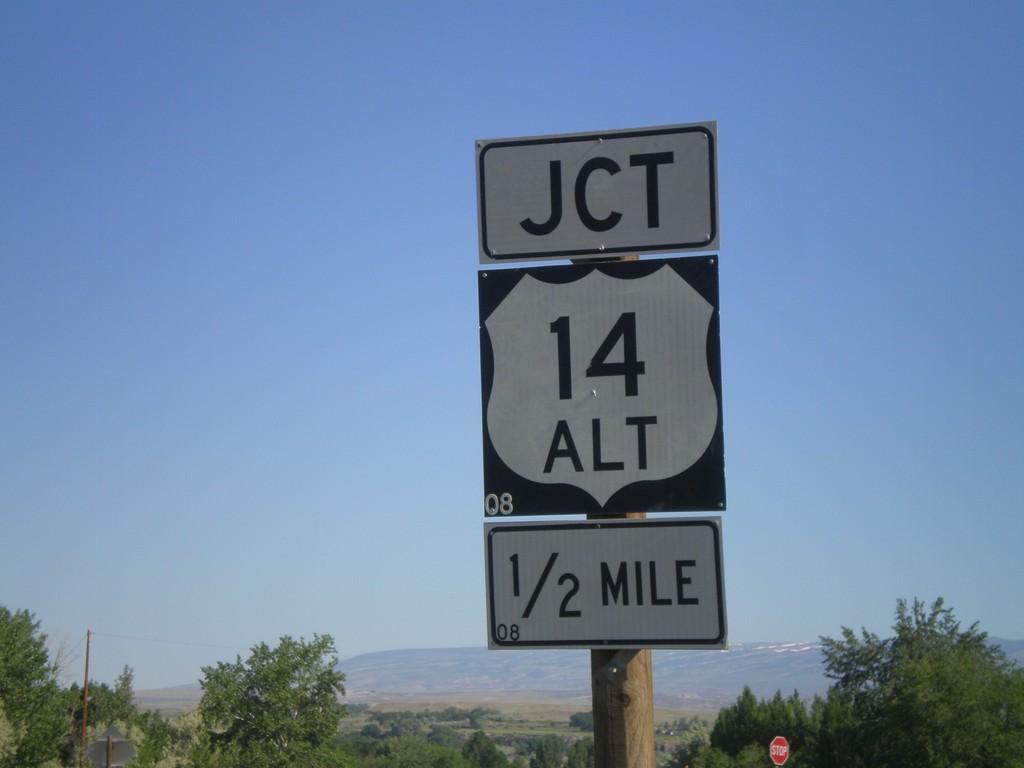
top-left (0, 618), bottom-right (347, 768)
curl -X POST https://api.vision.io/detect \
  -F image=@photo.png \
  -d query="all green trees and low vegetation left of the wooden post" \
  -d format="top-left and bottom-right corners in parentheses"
top-left (0, 618), bottom-right (593, 768)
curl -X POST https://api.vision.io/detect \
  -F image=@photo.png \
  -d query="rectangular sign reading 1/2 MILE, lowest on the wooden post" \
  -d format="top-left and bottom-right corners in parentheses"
top-left (484, 517), bottom-right (727, 648)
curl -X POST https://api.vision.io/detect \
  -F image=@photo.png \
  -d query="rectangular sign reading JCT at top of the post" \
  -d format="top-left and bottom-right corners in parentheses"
top-left (476, 122), bottom-right (719, 264)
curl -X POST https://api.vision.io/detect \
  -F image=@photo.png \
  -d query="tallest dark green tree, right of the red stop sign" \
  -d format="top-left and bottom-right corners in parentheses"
top-left (816, 598), bottom-right (1024, 768)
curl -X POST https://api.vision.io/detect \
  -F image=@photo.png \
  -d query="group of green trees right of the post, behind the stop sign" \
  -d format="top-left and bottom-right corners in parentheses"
top-left (670, 598), bottom-right (1024, 768)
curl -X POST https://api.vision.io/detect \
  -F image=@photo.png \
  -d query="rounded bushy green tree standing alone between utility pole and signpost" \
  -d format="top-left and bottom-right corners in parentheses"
top-left (198, 635), bottom-right (345, 768)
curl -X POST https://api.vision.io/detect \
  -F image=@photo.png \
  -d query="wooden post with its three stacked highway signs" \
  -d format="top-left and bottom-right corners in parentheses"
top-left (476, 122), bottom-right (726, 768)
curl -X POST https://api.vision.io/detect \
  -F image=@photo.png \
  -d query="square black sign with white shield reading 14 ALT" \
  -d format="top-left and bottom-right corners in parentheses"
top-left (478, 257), bottom-right (725, 516)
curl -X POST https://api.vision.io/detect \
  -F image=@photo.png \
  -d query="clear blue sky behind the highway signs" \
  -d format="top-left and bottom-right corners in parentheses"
top-left (0, 2), bottom-right (1024, 688)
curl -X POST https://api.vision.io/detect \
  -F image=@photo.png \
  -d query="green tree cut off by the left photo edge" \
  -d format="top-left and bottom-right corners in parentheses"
top-left (0, 605), bottom-right (71, 768)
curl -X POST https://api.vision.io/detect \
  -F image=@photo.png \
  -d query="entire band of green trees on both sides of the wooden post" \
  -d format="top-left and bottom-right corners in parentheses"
top-left (0, 599), bottom-right (1024, 768)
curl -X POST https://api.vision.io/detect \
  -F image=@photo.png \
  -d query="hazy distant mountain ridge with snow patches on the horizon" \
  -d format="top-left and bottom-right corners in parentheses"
top-left (137, 638), bottom-right (1024, 710)
